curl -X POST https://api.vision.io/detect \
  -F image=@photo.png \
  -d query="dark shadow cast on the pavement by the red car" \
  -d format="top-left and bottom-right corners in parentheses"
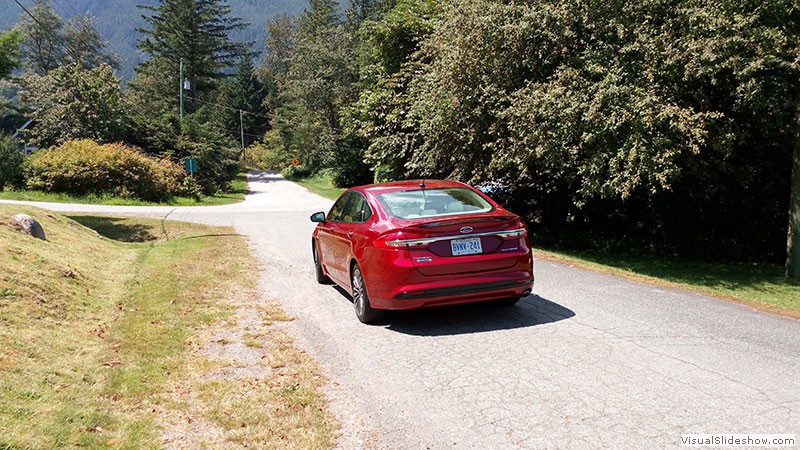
top-left (334, 286), bottom-right (575, 336)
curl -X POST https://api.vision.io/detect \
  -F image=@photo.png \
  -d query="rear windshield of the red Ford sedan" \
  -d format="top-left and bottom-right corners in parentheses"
top-left (378, 188), bottom-right (494, 219)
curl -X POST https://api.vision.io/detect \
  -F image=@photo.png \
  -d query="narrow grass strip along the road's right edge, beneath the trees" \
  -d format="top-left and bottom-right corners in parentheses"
top-left (537, 250), bottom-right (800, 318)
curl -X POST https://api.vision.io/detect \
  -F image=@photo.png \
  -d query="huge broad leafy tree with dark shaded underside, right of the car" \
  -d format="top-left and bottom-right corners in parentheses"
top-left (374, 1), bottom-right (798, 258)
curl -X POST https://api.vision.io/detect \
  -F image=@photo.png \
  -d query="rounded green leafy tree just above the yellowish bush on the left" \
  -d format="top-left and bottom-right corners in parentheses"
top-left (22, 64), bottom-right (127, 146)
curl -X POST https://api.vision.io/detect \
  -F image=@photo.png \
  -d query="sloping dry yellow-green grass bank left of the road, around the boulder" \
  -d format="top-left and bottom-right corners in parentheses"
top-left (0, 205), bottom-right (335, 449)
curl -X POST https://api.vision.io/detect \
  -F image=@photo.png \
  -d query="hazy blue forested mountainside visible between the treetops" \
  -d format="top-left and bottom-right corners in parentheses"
top-left (0, 0), bottom-right (308, 79)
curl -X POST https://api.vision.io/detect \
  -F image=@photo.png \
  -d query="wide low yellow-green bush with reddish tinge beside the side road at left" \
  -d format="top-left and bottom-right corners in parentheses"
top-left (24, 139), bottom-right (185, 201)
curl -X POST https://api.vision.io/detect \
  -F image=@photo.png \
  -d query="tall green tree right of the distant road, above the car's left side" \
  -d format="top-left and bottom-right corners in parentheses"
top-left (273, 0), bottom-right (367, 184)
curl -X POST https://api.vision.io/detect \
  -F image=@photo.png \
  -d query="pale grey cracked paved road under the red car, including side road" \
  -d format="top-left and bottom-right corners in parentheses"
top-left (3, 173), bottom-right (800, 449)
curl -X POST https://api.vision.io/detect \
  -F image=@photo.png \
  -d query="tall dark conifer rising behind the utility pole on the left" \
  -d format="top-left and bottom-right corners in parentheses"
top-left (137, 0), bottom-right (249, 112)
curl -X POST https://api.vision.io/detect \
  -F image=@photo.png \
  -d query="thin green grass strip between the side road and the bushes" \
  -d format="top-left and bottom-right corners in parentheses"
top-left (0, 171), bottom-right (247, 206)
